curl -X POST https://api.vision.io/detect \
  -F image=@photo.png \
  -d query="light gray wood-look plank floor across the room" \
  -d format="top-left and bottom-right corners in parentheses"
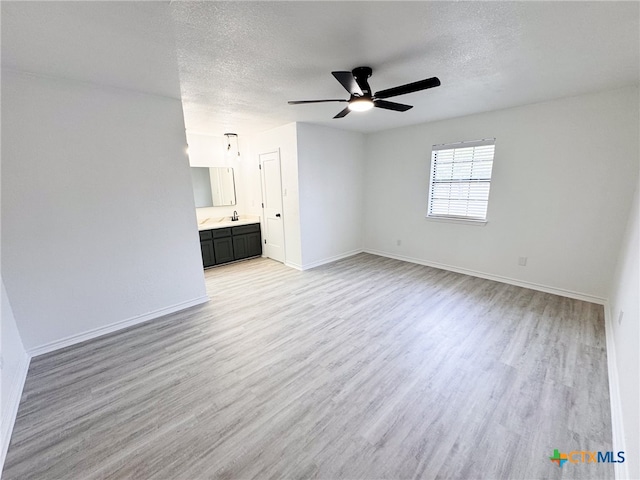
top-left (3, 254), bottom-right (613, 480)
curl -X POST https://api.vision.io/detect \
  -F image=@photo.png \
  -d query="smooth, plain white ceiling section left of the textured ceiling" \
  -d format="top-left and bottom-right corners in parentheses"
top-left (0, 0), bottom-right (180, 98)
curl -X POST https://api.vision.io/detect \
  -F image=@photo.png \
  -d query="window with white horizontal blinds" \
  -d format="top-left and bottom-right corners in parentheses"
top-left (427, 138), bottom-right (496, 222)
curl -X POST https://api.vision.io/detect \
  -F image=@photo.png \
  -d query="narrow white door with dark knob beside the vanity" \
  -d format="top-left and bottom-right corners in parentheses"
top-left (259, 151), bottom-right (285, 263)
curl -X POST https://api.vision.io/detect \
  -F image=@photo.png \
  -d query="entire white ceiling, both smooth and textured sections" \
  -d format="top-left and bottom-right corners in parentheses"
top-left (2, 1), bottom-right (640, 136)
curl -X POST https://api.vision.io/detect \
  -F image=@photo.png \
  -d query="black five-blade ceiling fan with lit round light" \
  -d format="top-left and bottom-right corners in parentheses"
top-left (289, 67), bottom-right (440, 118)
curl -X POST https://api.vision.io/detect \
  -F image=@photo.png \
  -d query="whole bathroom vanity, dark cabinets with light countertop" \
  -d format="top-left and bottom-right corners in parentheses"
top-left (198, 216), bottom-right (262, 268)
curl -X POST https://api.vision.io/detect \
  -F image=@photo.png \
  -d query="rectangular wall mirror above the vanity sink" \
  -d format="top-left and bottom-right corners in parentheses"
top-left (191, 167), bottom-right (236, 208)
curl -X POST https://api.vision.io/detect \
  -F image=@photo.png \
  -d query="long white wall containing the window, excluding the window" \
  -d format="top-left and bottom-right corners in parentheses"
top-left (364, 88), bottom-right (638, 301)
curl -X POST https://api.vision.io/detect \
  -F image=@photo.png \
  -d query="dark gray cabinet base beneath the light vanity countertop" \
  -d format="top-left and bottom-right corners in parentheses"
top-left (200, 223), bottom-right (262, 268)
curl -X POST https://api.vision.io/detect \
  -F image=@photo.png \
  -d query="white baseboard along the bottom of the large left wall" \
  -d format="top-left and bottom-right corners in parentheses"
top-left (27, 295), bottom-right (209, 357)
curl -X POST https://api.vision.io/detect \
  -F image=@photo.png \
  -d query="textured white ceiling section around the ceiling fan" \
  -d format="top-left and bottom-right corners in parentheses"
top-left (171, 2), bottom-right (640, 134)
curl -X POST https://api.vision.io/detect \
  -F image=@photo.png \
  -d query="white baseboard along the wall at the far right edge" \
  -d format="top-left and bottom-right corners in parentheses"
top-left (604, 302), bottom-right (631, 480)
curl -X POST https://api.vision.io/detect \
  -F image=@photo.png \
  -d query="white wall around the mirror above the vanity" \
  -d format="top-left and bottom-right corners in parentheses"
top-left (187, 131), bottom-right (247, 221)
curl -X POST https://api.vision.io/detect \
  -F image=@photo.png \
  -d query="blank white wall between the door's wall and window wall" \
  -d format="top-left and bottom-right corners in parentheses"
top-left (297, 123), bottom-right (365, 268)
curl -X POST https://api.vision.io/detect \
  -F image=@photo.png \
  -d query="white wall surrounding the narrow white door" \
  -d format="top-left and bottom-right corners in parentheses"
top-left (250, 123), bottom-right (302, 268)
